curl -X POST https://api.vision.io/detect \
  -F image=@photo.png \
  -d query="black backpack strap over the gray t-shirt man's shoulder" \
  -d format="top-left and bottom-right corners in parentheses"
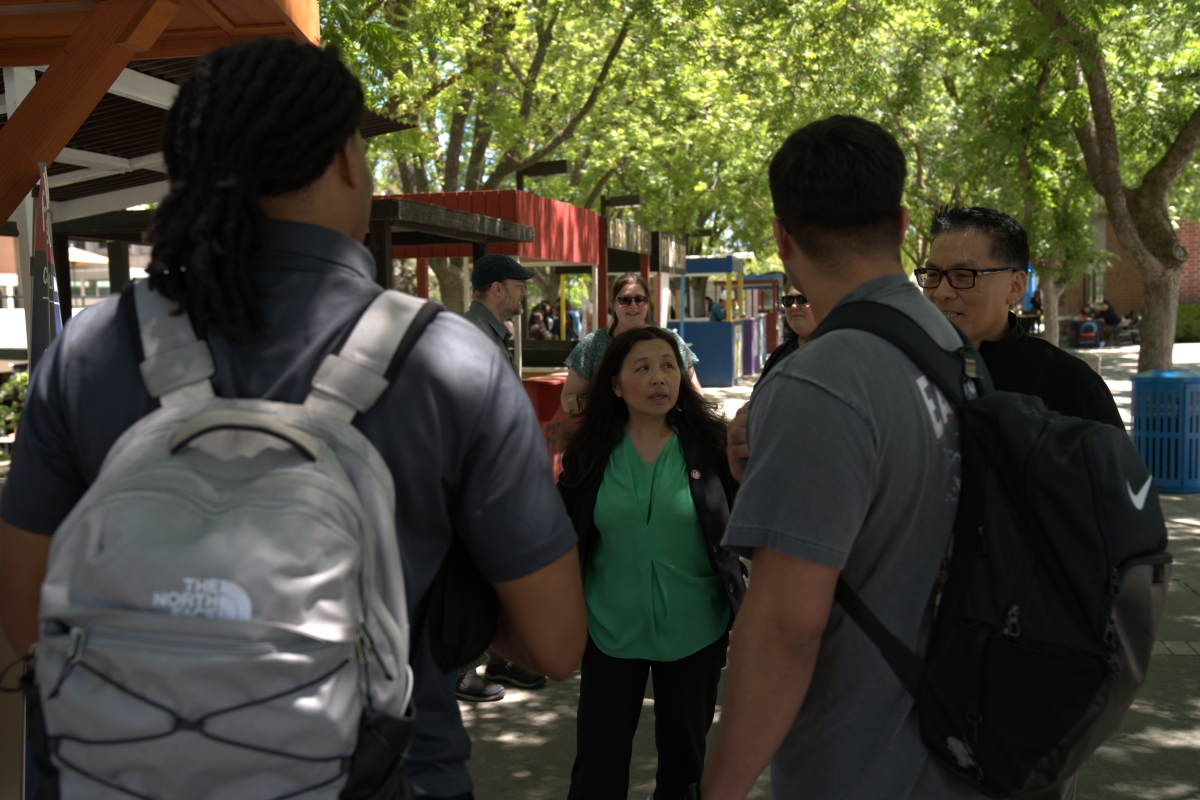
top-left (809, 300), bottom-right (992, 408)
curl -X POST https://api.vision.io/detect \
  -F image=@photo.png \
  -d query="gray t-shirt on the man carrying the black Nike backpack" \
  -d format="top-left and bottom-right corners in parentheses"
top-left (725, 275), bottom-right (979, 800)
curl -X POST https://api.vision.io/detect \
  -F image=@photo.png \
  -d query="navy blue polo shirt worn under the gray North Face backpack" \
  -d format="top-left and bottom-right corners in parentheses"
top-left (0, 222), bottom-right (575, 796)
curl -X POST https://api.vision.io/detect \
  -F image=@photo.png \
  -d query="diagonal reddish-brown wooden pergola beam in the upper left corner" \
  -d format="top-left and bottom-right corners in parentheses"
top-left (0, 0), bottom-right (179, 219)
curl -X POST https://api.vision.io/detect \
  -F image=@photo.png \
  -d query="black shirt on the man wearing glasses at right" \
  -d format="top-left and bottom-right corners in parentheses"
top-left (979, 313), bottom-right (1124, 428)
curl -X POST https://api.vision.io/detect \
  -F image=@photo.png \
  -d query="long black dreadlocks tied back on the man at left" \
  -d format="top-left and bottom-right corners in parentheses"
top-left (148, 37), bottom-right (366, 342)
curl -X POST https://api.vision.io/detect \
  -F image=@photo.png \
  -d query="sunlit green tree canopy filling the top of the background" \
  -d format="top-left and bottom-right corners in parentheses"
top-left (323, 0), bottom-right (1200, 362)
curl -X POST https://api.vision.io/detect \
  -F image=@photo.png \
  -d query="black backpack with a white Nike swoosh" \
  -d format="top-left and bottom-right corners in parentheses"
top-left (812, 302), bottom-right (1171, 798)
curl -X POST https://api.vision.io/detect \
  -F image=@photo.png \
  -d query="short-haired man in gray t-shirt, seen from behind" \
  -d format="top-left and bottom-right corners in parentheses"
top-left (702, 118), bottom-right (978, 800)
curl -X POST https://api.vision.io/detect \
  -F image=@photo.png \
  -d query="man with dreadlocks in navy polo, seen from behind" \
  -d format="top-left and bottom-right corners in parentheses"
top-left (0, 38), bottom-right (587, 798)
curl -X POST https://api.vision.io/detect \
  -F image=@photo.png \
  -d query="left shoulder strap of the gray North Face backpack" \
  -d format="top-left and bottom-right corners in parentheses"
top-left (126, 279), bottom-right (216, 407)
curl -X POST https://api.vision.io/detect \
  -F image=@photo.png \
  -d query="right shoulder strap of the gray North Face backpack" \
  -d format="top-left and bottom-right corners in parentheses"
top-left (304, 289), bottom-right (442, 422)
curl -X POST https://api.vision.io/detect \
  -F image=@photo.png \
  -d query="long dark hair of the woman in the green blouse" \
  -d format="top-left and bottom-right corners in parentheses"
top-left (560, 325), bottom-right (725, 488)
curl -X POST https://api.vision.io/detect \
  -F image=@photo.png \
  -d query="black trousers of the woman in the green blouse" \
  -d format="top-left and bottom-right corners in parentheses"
top-left (568, 633), bottom-right (730, 800)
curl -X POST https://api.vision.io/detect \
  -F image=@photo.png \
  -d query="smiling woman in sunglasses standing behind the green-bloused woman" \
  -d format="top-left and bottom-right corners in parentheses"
top-left (560, 272), bottom-right (700, 414)
